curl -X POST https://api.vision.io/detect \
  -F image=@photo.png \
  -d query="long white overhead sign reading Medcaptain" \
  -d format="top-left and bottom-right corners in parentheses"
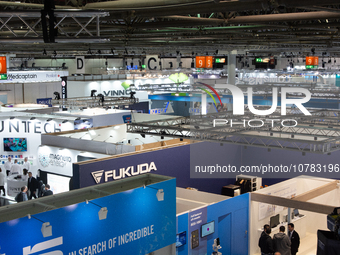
top-left (0, 71), bottom-right (68, 83)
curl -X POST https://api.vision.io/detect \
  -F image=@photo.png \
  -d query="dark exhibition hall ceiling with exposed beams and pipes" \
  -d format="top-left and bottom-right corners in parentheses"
top-left (0, 0), bottom-right (340, 57)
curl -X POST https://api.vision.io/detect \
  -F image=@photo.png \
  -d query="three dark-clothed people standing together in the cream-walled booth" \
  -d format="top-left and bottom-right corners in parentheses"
top-left (259, 223), bottom-right (300, 255)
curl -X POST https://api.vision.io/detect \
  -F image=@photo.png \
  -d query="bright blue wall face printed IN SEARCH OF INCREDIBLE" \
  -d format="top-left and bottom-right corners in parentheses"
top-left (0, 179), bottom-right (176, 255)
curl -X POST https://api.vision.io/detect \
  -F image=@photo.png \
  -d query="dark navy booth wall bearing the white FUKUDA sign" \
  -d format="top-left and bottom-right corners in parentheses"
top-left (73, 142), bottom-right (241, 194)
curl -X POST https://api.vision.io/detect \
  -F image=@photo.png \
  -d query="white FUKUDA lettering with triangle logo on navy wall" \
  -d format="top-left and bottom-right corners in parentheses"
top-left (91, 162), bottom-right (157, 184)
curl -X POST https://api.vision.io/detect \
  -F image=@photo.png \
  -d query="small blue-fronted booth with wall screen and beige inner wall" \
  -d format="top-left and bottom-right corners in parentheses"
top-left (176, 188), bottom-right (249, 255)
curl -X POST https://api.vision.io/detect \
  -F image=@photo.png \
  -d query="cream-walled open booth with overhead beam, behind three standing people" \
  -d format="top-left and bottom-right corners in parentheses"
top-left (249, 175), bottom-right (340, 254)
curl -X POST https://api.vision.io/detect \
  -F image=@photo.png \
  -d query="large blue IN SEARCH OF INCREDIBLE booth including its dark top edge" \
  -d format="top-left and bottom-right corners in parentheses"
top-left (0, 174), bottom-right (176, 255)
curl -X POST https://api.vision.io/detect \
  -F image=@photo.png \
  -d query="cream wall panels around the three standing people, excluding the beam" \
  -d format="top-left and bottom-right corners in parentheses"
top-left (249, 176), bottom-right (340, 254)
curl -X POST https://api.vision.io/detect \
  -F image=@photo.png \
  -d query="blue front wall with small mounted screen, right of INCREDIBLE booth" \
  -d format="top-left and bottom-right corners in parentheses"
top-left (177, 193), bottom-right (249, 255)
